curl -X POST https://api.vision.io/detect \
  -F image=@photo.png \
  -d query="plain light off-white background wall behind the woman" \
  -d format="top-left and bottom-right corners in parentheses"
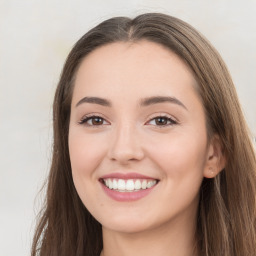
top-left (0, 0), bottom-right (256, 256)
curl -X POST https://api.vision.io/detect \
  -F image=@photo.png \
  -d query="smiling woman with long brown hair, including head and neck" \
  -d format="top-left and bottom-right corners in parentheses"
top-left (32, 13), bottom-right (256, 256)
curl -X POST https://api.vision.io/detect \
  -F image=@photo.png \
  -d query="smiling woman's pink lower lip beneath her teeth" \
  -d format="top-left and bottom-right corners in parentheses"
top-left (101, 183), bottom-right (156, 202)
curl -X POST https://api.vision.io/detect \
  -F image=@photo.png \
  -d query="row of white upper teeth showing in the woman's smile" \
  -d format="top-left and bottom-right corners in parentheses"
top-left (104, 179), bottom-right (157, 192)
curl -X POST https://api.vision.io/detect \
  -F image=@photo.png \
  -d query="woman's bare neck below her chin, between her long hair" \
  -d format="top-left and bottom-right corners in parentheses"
top-left (102, 214), bottom-right (197, 256)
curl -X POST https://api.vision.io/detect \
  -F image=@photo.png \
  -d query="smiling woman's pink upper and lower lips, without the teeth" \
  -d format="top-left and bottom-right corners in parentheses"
top-left (100, 173), bottom-right (156, 202)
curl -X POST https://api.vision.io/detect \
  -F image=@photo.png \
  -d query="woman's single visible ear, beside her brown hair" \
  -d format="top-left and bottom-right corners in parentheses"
top-left (204, 135), bottom-right (226, 178)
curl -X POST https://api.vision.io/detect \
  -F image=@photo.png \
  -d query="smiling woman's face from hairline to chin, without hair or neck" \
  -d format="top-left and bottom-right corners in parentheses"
top-left (68, 41), bottom-right (214, 232)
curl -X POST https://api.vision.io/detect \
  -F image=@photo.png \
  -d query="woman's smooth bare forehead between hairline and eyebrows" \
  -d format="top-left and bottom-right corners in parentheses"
top-left (73, 41), bottom-right (200, 108)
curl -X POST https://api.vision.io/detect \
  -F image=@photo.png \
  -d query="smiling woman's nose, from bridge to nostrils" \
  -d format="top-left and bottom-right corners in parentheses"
top-left (108, 125), bottom-right (144, 165)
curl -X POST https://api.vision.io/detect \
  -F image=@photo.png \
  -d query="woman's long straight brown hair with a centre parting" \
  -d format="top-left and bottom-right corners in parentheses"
top-left (31, 13), bottom-right (256, 256)
